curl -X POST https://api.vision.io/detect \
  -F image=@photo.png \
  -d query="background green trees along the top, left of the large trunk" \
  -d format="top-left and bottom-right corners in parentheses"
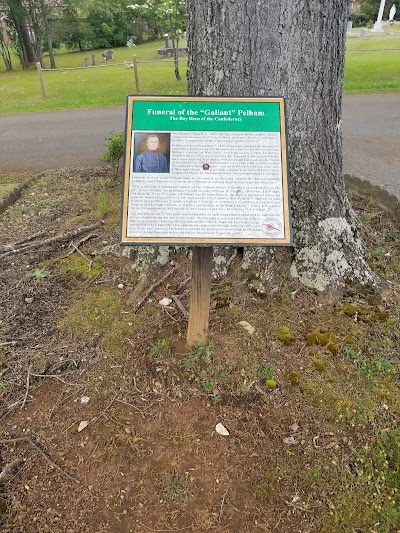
top-left (0, 0), bottom-right (186, 68)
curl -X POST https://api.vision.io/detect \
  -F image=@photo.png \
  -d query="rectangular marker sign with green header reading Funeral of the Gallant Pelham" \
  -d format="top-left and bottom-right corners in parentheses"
top-left (121, 96), bottom-right (292, 246)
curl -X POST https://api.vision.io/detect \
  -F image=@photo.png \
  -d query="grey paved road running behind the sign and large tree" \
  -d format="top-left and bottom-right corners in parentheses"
top-left (0, 93), bottom-right (400, 198)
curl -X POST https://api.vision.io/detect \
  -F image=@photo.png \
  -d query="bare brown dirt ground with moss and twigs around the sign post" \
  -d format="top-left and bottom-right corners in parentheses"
top-left (0, 169), bottom-right (400, 533)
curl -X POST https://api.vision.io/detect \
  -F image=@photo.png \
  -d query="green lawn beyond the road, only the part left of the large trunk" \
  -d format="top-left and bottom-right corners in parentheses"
top-left (0, 41), bottom-right (187, 114)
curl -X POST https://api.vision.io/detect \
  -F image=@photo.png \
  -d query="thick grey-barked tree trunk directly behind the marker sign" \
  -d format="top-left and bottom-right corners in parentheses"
top-left (187, 0), bottom-right (380, 295)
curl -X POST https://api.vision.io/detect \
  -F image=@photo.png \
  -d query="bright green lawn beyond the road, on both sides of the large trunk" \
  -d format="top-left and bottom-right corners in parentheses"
top-left (0, 28), bottom-right (400, 114)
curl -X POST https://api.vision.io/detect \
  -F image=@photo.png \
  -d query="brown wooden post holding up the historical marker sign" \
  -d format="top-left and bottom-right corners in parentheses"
top-left (187, 246), bottom-right (213, 346)
